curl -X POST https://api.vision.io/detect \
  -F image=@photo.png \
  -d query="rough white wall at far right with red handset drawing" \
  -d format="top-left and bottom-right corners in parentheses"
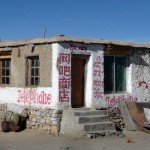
top-left (130, 49), bottom-right (150, 102)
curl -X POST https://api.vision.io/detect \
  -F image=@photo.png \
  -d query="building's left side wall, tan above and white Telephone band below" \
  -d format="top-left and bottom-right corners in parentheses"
top-left (0, 44), bottom-right (58, 109)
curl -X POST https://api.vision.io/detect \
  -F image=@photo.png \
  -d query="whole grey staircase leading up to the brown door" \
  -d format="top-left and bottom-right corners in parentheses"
top-left (60, 108), bottom-right (116, 137)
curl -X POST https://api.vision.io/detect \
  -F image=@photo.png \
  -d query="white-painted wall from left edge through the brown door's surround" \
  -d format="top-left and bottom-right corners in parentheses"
top-left (0, 42), bottom-right (105, 109)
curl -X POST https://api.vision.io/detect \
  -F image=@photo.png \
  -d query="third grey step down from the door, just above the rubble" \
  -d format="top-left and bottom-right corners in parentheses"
top-left (84, 122), bottom-right (116, 131)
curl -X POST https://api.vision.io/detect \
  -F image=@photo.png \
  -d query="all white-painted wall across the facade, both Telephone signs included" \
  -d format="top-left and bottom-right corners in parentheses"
top-left (0, 43), bottom-right (150, 109)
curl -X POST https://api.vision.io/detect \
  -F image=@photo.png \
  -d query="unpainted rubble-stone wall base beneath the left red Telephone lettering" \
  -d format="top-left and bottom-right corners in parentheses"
top-left (0, 104), bottom-right (62, 135)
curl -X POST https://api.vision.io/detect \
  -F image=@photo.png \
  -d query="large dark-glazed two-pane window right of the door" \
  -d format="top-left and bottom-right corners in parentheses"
top-left (104, 56), bottom-right (126, 93)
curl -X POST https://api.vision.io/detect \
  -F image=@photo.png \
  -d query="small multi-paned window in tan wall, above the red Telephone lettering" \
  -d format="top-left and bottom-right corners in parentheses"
top-left (28, 57), bottom-right (40, 86)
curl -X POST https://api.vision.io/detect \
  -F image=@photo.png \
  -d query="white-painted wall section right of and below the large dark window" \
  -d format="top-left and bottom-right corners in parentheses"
top-left (105, 49), bottom-right (150, 107)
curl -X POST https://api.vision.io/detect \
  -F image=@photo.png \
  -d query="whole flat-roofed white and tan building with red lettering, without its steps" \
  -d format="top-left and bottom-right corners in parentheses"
top-left (0, 36), bottom-right (150, 133)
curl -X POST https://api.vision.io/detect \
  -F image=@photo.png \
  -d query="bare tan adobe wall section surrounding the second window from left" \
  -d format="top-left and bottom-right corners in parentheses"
top-left (10, 44), bottom-right (52, 87)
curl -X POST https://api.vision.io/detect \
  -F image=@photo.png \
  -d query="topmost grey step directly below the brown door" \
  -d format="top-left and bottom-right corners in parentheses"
top-left (74, 110), bottom-right (105, 116)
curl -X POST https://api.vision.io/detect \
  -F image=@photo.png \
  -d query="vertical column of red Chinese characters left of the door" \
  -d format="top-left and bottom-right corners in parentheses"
top-left (59, 54), bottom-right (71, 102)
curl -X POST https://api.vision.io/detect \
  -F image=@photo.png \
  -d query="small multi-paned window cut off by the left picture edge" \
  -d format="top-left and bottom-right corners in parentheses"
top-left (0, 59), bottom-right (11, 84)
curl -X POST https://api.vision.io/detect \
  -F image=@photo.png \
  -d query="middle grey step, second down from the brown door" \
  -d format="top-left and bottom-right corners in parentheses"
top-left (78, 115), bottom-right (110, 124)
